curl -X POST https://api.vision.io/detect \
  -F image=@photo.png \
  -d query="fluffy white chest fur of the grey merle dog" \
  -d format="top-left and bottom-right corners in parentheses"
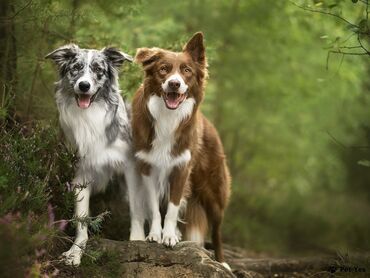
top-left (57, 94), bottom-right (128, 168)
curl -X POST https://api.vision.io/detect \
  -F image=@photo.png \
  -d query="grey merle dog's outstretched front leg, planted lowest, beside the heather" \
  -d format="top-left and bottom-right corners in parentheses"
top-left (62, 178), bottom-right (90, 266)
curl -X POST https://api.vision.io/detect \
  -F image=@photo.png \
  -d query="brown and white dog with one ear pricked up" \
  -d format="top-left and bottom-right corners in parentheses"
top-left (132, 33), bottom-right (230, 268)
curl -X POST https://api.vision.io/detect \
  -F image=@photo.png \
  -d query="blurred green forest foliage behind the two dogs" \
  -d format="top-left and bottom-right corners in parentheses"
top-left (0, 0), bottom-right (370, 268)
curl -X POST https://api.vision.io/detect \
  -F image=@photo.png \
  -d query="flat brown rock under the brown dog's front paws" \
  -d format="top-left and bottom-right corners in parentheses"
top-left (94, 239), bottom-right (234, 278)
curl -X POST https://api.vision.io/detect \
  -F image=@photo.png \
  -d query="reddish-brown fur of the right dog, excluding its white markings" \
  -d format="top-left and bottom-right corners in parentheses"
top-left (132, 33), bottom-right (230, 262)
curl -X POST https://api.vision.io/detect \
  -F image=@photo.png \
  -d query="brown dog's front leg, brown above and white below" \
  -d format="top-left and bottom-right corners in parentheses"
top-left (162, 166), bottom-right (190, 247)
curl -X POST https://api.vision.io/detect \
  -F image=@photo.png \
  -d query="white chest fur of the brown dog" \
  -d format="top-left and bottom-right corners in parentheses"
top-left (136, 95), bottom-right (195, 195)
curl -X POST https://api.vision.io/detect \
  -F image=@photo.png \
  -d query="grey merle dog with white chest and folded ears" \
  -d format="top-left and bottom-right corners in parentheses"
top-left (46, 44), bottom-right (145, 265)
